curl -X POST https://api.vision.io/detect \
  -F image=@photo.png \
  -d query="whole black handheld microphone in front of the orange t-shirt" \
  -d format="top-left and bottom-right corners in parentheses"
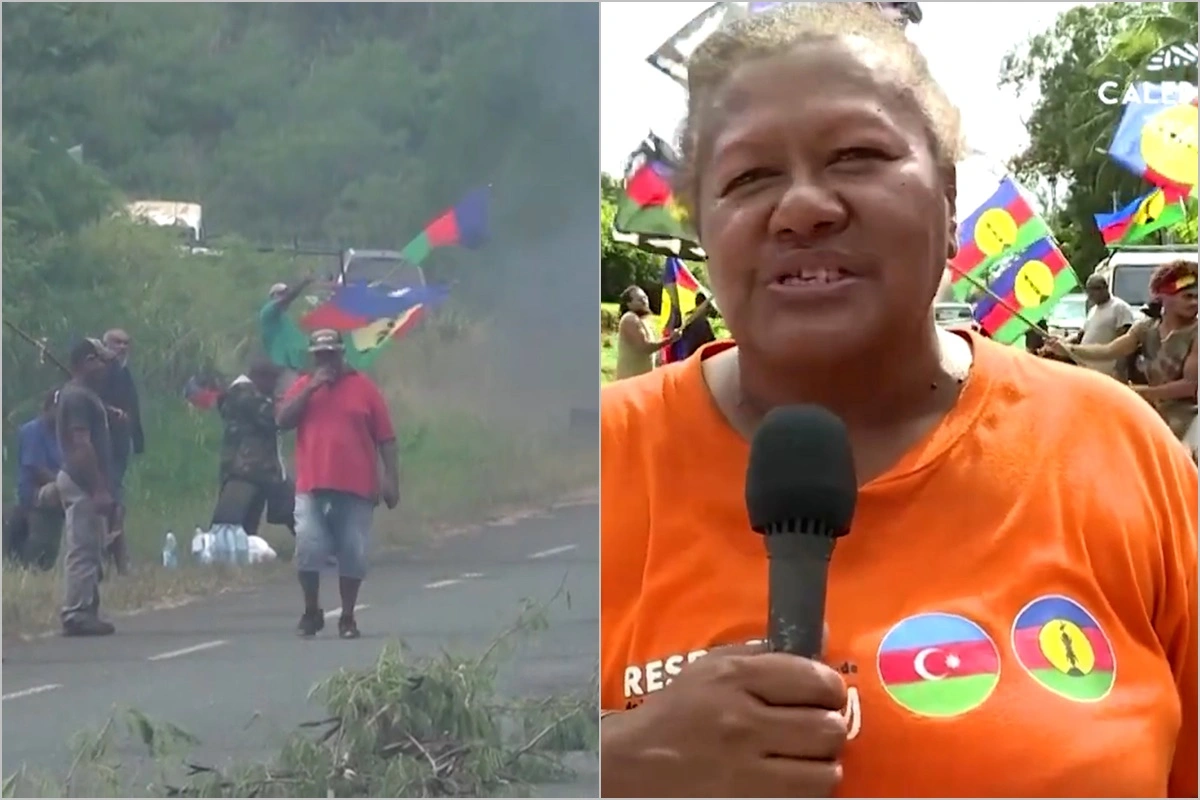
top-left (746, 405), bottom-right (858, 658)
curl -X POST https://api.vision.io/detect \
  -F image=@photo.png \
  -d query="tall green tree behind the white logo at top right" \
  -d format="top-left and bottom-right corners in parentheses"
top-left (1000, 2), bottom-right (1198, 276)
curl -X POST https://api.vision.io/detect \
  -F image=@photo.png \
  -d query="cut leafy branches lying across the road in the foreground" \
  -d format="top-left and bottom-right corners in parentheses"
top-left (2, 596), bottom-right (600, 798)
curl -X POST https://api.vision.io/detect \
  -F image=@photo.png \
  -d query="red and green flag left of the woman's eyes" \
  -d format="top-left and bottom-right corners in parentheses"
top-left (612, 133), bottom-right (704, 261)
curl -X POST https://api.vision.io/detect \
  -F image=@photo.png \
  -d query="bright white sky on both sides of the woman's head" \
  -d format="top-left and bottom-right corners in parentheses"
top-left (600, 2), bottom-right (1087, 215)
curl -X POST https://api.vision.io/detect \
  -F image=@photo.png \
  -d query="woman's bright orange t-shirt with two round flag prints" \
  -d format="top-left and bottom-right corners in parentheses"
top-left (600, 336), bottom-right (1198, 798)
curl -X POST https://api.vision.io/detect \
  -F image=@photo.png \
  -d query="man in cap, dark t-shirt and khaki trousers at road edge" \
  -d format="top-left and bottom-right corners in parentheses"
top-left (55, 338), bottom-right (116, 636)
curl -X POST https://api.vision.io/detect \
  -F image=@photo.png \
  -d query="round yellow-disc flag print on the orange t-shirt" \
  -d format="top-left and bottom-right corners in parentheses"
top-left (1013, 595), bottom-right (1116, 703)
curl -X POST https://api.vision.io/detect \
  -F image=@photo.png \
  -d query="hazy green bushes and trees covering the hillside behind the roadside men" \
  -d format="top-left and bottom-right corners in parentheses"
top-left (2, 4), bottom-right (598, 563)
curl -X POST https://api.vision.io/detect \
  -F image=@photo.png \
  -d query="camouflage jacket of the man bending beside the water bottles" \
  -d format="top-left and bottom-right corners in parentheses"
top-left (217, 375), bottom-right (283, 486)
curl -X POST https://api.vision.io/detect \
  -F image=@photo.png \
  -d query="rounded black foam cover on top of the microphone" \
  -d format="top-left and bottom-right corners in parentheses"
top-left (746, 405), bottom-right (858, 536)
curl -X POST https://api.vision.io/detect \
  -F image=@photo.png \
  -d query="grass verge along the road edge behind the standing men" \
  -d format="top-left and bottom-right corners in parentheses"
top-left (2, 325), bottom-right (598, 637)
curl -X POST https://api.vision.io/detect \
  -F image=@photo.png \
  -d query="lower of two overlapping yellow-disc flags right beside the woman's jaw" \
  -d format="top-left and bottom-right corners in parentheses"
top-left (974, 239), bottom-right (1079, 344)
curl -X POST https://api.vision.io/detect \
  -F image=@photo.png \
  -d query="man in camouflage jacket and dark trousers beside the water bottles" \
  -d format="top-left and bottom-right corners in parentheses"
top-left (212, 357), bottom-right (295, 536)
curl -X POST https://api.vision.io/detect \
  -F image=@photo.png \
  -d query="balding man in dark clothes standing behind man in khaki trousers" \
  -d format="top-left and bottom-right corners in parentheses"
top-left (100, 327), bottom-right (145, 573)
